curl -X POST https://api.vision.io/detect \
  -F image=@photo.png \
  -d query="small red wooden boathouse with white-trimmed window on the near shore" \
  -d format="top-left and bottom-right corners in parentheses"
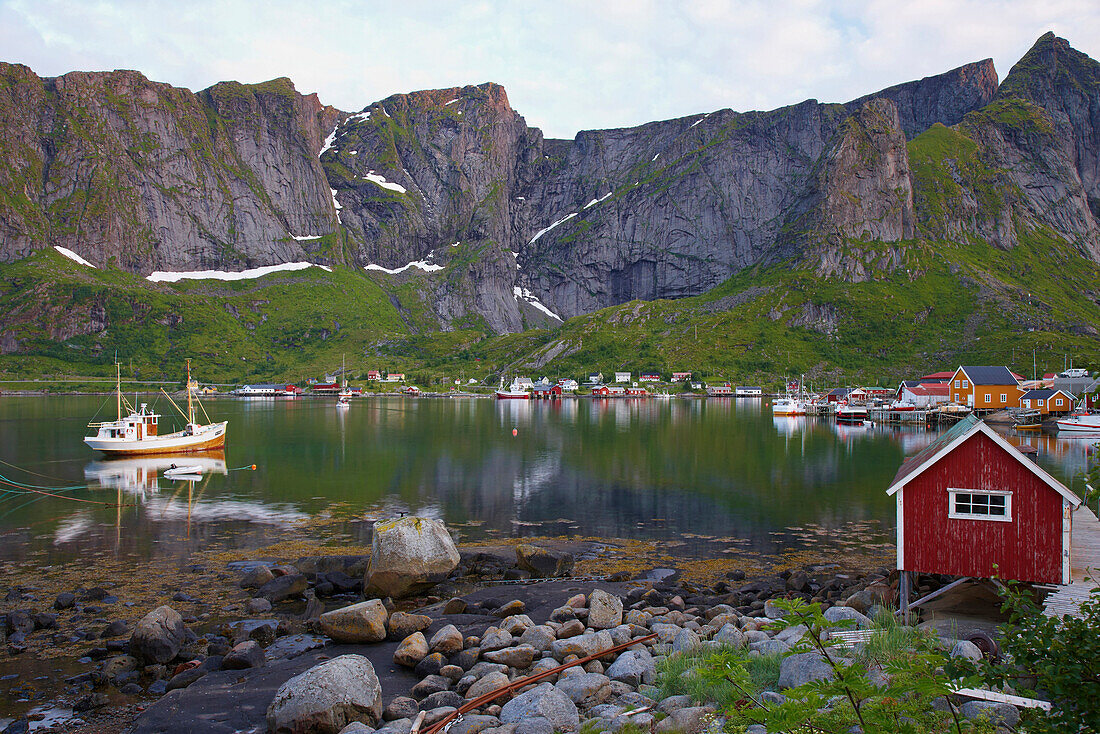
top-left (887, 416), bottom-right (1081, 611)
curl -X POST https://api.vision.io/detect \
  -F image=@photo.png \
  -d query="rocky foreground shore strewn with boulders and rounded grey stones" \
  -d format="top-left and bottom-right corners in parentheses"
top-left (3, 518), bottom-right (1019, 734)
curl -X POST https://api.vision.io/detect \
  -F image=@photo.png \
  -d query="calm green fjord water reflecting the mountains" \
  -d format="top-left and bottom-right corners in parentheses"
top-left (0, 396), bottom-right (1095, 562)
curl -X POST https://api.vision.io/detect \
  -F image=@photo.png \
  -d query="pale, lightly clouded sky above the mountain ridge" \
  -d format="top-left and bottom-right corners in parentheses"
top-left (0, 0), bottom-right (1100, 138)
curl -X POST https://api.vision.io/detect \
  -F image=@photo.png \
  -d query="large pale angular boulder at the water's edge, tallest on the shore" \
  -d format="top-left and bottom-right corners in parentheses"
top-left (363, 517), bottom-right (459, 599)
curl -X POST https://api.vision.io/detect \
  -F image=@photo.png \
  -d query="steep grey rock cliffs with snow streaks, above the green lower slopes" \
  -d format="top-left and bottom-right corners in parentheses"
top-left (0, 35), bottom-right (1100, 331)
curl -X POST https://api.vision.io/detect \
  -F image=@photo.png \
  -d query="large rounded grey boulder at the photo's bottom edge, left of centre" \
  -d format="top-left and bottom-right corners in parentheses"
top-left (267, 655), bottom-right (382, 734)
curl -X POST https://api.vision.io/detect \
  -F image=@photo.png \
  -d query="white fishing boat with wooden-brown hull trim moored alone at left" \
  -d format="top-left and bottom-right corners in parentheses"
top-left (84, 360), bottom-right (229, 456)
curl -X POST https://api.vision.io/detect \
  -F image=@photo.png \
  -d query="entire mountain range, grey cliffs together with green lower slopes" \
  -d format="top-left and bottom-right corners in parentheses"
top-left (0, 34), bottom-right (1100, 385)
